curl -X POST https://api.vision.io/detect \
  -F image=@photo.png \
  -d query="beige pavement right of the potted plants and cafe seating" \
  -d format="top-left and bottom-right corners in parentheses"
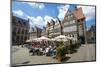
top-left (67, 44), bottom-right (95, 62)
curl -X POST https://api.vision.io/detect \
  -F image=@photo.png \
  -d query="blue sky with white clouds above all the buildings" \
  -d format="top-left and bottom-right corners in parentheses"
top-left (12, 1), bottom-right (96, 28)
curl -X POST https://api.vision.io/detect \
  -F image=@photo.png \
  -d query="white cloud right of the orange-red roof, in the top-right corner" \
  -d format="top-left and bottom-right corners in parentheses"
top-left (78, 6), bottom-right (95, 21)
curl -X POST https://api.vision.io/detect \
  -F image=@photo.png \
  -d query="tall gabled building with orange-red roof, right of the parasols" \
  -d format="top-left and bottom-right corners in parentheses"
top-left (62, 8), bottom-right (85, 43)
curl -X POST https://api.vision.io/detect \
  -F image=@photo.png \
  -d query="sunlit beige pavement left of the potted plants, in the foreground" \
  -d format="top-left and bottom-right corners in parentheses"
top-left (12, 47), bottom-right (58, 64)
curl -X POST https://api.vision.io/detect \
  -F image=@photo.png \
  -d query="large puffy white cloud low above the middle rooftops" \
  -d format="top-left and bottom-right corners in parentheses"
top-left (27, 15), bottom-right (56, 27)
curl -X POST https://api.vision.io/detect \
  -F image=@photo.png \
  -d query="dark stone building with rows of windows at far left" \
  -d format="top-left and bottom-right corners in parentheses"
top-left (11, 16), bottom-right (29, 45)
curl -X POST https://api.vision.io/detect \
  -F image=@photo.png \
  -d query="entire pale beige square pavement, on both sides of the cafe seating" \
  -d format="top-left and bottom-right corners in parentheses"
top-left (11, 44), bottom-right (95, 65)
